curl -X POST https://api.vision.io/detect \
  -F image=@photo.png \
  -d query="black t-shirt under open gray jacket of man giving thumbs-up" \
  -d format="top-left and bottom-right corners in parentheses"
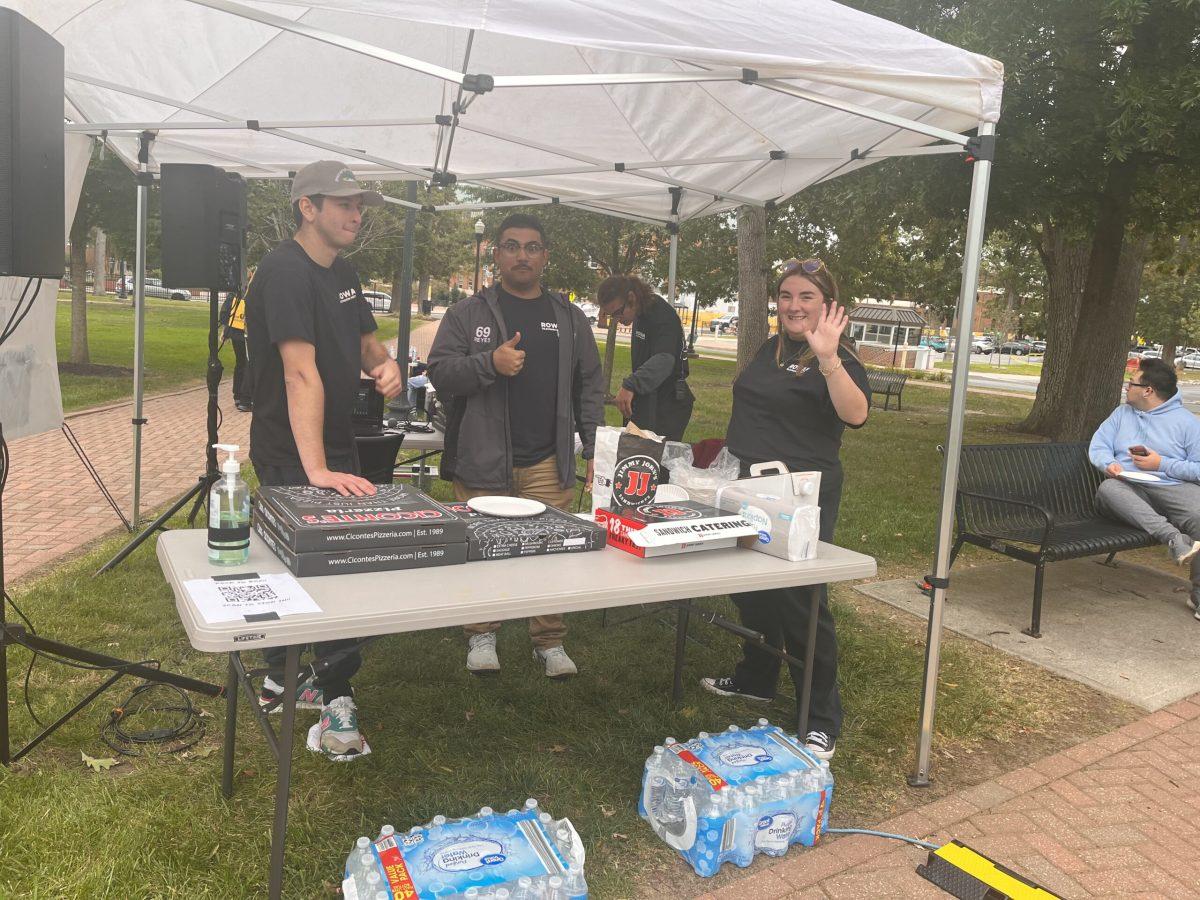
top-left (496, 288), bottom-right (559, 468)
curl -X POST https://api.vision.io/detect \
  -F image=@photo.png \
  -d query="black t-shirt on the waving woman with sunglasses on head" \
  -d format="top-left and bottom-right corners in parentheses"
top-left (726, 335), bottom-right (871, 474)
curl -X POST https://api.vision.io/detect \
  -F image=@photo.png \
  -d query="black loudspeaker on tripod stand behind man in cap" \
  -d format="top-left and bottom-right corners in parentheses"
top-left (160, 163), bottom-right (246, 290)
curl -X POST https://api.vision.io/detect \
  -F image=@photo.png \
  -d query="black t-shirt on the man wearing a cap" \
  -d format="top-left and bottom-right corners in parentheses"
top-left (246, 240), bottom-right (376, 466)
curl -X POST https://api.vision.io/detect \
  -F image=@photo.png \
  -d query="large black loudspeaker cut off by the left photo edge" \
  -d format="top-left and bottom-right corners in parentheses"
top-left (0, 8), bottom-right (66, 278)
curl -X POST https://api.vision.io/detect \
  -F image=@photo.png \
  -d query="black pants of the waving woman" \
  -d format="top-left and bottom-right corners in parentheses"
top-left (730, 472), bottom-right (841, 738)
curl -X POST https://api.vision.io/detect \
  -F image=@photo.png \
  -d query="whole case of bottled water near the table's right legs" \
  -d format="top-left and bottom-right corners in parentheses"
top-left (637, 719), bottom-right (833, 877)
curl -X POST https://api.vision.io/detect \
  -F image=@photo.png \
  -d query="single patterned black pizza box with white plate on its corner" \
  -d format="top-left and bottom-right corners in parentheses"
top-left (445, 503), bottom-right (607, 559)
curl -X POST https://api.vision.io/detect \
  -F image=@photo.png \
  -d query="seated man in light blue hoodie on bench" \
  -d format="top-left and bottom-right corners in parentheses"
top-left (1087, 359), bottom-right (1200, 619)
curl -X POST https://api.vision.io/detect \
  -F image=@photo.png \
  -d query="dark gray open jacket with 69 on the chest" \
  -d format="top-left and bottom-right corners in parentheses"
top-left (428, 287), bottom-right (604, 490)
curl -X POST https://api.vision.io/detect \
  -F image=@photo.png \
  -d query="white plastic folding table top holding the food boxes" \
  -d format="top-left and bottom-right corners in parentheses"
top-left (157, 528), bottom-right (875, 653)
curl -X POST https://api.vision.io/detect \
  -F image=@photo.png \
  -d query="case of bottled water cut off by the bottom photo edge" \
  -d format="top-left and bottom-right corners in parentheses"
top-left (342, 798), bottom-right (588, 900)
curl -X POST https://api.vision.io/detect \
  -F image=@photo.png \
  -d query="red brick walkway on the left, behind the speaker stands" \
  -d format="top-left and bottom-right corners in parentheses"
top-left (4, 322), bottom-right (438, 584)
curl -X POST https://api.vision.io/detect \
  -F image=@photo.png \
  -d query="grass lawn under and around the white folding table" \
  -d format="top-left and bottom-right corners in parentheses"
top-left (0, 355), bottom-right (1122, 899)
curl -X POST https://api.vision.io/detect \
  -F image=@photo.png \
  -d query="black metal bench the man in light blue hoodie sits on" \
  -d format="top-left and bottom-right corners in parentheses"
top-left (950, 443), bottom-right (1157, 637)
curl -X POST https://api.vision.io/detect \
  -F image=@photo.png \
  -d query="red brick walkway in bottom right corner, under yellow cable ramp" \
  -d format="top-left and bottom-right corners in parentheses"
top-left (704, 695), bottom-right (1200, 900)
